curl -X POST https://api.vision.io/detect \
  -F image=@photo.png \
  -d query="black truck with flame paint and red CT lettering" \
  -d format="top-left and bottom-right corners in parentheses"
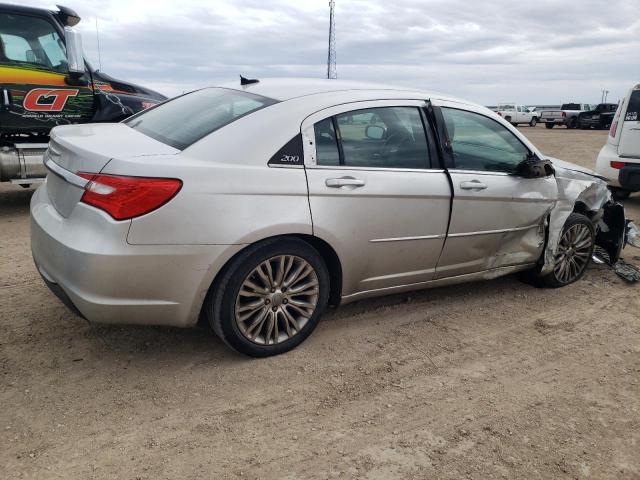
top-left (0, 4), bottom-right (166, 186)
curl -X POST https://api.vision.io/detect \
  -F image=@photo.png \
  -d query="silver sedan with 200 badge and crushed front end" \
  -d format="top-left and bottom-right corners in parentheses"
top-left (31, 79), bottom-right (625, 356)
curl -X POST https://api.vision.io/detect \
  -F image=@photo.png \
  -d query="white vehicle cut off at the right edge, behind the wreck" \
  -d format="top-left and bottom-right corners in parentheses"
top-left (596, 84), bottom-right (640, 200)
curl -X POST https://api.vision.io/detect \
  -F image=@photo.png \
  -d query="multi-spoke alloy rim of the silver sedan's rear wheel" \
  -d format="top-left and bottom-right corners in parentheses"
top-left (235, 255), bottom-right (320, 345)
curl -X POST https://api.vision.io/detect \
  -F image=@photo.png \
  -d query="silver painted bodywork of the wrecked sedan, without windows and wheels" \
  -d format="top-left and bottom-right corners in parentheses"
top-left (31, 80), bottom-right (620, 326)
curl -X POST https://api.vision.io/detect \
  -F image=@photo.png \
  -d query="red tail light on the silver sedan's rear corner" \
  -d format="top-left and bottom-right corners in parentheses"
top-left (78, 172), bottom-right (182, 220)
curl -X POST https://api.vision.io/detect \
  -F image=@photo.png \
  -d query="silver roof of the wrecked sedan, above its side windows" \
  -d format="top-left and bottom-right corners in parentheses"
top-left (222, 78), bottom-right (471, 104)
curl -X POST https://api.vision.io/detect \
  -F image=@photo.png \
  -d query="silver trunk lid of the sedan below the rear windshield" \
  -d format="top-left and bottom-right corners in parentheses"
top-left (44, 123), bottom-right (179, 217)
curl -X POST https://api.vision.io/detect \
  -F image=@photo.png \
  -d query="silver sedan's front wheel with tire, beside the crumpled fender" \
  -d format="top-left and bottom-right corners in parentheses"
top-left (540, 213), bottom-right (596, 288)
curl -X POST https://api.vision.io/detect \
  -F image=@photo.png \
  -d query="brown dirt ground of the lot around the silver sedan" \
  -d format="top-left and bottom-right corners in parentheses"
top-left (0, 127), bottom-right (640, 480)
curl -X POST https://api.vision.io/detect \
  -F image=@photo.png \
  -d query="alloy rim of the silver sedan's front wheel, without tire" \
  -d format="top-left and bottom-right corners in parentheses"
top-left (554, 223), bottom-right (593, 284)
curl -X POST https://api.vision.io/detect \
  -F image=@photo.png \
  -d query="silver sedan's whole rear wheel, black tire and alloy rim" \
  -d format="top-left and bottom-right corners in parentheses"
top-left (205, 238), bottom-right (329, 357)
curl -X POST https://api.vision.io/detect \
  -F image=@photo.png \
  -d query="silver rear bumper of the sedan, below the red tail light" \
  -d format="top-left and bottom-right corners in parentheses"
top-left (31, 184), bottom-right (242, 327)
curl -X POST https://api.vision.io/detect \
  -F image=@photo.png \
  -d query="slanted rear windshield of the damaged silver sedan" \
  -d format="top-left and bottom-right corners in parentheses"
top-left (124, 88), bottom-right (277, 150)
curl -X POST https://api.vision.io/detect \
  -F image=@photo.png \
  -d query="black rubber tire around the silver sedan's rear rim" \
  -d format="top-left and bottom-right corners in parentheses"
top-left (204, 237), bottom-right (330, 357)
